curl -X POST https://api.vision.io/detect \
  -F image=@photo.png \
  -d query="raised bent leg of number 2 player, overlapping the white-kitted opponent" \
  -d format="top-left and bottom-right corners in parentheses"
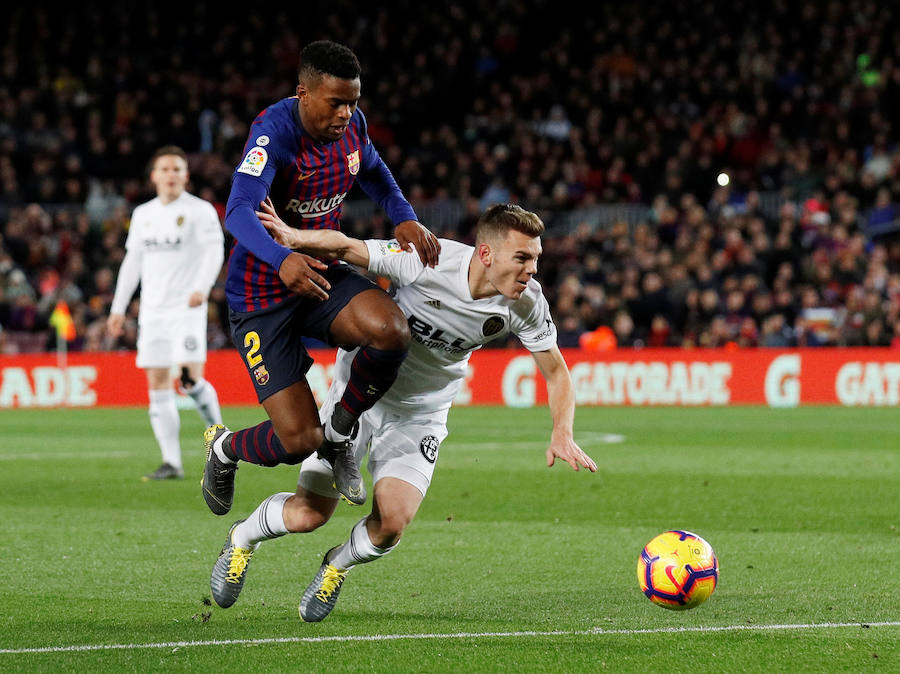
top-left (319, 289), bottom-right (410, 505)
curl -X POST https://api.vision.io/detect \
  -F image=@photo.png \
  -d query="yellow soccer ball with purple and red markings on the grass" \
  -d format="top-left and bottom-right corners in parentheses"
top-left (638, 530), bottom-right (719, 611)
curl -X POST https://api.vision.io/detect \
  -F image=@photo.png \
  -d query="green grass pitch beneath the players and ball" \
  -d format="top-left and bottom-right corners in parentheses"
top-left (0, 407), bottom-right (900, 672)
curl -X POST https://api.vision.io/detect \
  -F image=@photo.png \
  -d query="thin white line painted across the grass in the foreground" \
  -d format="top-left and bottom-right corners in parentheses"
top-left (0, 621), bottom-right (900, 655)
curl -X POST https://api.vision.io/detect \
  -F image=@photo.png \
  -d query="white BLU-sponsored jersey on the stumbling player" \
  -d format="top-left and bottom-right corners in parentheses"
top-left (335, 239), bottom-right (556, 412)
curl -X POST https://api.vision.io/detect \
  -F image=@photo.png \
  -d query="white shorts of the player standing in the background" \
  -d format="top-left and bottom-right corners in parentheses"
top-left (137, 303), bottom-right (207, 368)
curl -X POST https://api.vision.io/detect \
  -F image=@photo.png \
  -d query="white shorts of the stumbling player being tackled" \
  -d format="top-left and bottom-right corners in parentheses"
top-left (297, 395), bottom-right (447, 498)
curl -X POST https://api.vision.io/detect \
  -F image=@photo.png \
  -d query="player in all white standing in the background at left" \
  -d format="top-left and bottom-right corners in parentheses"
top-left (106, 145), bottom-right (225, 481)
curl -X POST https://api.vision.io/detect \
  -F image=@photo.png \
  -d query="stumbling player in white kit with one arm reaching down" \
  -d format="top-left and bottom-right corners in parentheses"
top-left (210, 204), bottom-right (597, 622)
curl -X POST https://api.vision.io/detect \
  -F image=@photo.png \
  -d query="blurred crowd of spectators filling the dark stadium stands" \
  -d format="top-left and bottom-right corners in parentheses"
top-left (0, 0), bottom-right (900, 353)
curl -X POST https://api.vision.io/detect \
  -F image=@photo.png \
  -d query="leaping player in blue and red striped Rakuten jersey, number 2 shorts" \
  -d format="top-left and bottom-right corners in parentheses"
top-left (201, 41), bottom-right (440, 515)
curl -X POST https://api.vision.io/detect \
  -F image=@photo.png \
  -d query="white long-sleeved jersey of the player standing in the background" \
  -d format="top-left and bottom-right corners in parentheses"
top-left (111, 192), bottom-right (225, 317)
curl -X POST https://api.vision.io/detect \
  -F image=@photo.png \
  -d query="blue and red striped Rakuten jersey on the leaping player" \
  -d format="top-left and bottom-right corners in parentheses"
top-left (225, 96), bottom-right (417, 311)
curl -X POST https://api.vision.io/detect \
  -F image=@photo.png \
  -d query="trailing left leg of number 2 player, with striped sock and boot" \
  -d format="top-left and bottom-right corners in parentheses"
top-left (200, 379), bottom-right (324, 515)
